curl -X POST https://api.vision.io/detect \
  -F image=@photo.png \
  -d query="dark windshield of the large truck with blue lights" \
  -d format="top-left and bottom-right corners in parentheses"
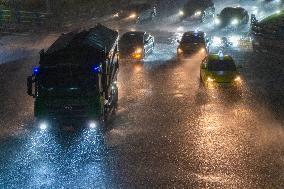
top-left (39, 66), bottom-right (97, 90)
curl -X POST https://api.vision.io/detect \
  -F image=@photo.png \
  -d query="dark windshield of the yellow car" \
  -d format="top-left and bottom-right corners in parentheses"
top-left (208, 60), bottom-right (237, 71)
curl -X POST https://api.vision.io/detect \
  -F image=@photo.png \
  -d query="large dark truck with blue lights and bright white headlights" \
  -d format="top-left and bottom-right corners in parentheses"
top-left (27, 24), bottom-right (119, 129)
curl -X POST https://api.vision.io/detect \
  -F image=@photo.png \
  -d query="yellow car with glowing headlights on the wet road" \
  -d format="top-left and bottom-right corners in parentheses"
top-left (200, 53), bottom-right (242, 85)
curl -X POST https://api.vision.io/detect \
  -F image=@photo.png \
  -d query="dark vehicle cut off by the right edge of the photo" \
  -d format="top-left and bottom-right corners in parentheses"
top-left (251, 11), bottom-right (284, 52)
